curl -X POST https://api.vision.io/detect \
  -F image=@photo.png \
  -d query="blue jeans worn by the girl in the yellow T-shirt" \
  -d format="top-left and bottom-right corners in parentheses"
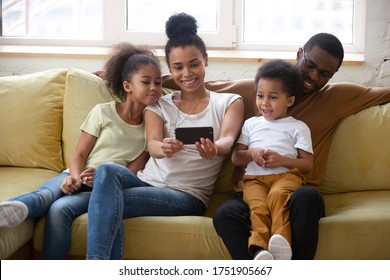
top-left (10, 172), bottom-right (91, 260)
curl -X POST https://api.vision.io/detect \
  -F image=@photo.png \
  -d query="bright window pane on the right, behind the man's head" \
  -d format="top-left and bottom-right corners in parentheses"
top-left (238, 0), bottom-right (365, 52)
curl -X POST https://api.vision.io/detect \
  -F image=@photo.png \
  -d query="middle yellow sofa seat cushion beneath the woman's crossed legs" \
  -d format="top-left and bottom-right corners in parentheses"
top-left (33, 214), bottom-right (230, 260)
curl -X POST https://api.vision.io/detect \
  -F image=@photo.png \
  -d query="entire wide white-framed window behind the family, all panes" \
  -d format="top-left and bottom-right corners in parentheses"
top-left (0, 0), bottom-right (366, 52)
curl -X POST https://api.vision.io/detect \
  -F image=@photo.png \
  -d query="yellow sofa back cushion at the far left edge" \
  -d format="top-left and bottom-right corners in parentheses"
top-left (0, 68), bottom-right (67, 172)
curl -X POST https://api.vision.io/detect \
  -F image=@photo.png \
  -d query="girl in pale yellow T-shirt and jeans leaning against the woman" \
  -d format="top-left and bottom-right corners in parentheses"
top-left (0, 43), bottom-right (162, 259)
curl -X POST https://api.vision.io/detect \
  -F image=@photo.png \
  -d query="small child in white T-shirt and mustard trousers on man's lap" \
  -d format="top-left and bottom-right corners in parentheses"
top-left (232, 60), bottom-right (313, 259)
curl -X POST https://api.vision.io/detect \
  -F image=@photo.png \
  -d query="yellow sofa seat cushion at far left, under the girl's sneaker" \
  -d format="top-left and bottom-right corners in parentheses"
top-left (0, 166), bottom-right (57, 260)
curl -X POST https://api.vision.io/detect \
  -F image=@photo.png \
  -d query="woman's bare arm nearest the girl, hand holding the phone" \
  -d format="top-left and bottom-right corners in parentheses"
top-left (144, 110), bottom-right (184, 158)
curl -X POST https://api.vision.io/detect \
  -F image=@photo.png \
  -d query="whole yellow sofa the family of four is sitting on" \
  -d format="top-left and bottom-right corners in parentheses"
top-left (0, 68), bottom-right (390, 259)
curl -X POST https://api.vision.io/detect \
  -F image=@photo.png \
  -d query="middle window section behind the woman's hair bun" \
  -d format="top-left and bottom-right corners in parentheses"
top-left (103, 0), bottom-right (233, 48)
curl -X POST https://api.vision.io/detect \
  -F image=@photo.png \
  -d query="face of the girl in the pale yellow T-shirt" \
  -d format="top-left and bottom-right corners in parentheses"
top-left (123, 64), bottom-right (162, 106)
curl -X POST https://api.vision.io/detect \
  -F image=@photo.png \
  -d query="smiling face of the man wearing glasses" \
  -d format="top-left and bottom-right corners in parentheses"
top-left (297, 45), bottom-right (340, 93)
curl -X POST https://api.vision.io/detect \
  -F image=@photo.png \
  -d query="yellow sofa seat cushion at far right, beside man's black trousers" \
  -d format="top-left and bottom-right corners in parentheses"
top-left (316, 190), bottom-right (390, 260)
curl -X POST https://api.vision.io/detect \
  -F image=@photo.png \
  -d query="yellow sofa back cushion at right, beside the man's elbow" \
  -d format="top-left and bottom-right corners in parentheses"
top-left (320, 103), bottom-right (390, 193)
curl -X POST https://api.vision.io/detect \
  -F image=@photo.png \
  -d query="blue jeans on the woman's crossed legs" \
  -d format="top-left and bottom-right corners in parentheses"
top-left (87, 163), bottom-right (205, 260)
